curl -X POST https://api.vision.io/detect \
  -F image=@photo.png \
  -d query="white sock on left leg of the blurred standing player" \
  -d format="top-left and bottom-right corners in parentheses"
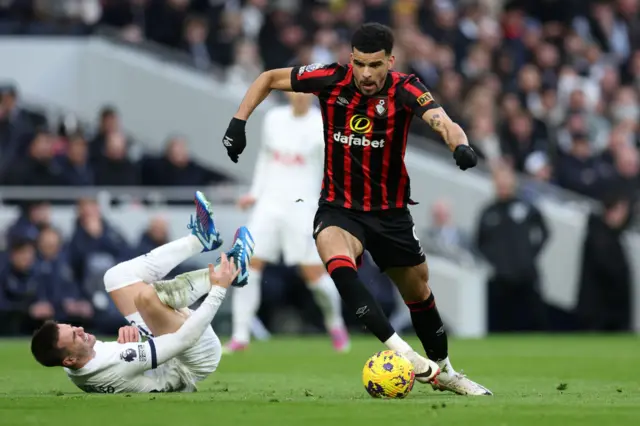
top-left (231, 268), bottom-right (262, 343)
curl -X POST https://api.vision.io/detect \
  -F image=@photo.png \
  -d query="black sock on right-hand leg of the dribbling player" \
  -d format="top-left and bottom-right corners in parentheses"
top-left (406, 292), bottom-right (449, 361)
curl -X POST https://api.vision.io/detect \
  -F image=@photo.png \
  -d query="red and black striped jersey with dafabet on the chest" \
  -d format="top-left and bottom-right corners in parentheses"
top-left (291, 63), bottom-right (438, 211)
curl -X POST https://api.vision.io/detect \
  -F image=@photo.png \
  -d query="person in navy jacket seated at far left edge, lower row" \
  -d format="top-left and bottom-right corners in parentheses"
top-left (0, 240), bottom-right (55, 334)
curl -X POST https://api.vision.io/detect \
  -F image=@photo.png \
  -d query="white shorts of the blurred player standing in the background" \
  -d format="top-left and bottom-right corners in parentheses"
top-left (248, 202), bottom-right (322, 266)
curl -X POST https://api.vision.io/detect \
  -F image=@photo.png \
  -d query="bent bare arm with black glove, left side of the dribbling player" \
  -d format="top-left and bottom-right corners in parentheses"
top-left (222, 68), bottom-right (293, 163)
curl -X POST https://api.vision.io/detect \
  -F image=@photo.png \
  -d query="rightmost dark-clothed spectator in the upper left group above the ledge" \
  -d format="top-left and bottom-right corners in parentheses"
top-left (142, 136), bottom-right (226, 186)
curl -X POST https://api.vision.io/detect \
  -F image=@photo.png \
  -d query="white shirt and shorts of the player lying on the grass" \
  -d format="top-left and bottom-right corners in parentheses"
top-left (65, 287), bottom-right (226, 393)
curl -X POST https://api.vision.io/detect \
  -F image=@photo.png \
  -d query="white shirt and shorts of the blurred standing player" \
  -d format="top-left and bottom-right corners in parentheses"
top-left (249, 105), bottom-right (324, 265)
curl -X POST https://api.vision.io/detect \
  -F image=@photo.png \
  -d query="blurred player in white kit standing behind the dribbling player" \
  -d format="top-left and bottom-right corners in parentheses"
top-left (224, 93), bottom-right (349, 352)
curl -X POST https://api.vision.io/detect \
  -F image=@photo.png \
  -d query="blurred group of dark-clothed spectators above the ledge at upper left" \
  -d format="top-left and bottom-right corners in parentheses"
top-left (0, 85), bottom-right (227, 187)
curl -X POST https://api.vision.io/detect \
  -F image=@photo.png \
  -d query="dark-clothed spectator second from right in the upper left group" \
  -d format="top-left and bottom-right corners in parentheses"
top-left (95, 132), bottom-right (140, 186)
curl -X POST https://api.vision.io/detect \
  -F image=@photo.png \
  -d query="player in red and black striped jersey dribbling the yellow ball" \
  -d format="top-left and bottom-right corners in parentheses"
top-left (222, 24), bottom-right (491, 395)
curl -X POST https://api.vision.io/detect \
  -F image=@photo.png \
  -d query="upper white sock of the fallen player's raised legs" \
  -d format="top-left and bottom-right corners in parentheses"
top-left (104, 235), bottom-right (202, 292)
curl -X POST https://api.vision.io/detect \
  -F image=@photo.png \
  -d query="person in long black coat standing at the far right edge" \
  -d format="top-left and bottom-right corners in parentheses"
top-left (576, 194), bottom-right (632, 331)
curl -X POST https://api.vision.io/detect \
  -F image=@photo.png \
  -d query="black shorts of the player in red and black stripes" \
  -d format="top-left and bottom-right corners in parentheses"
top-left (313, 201), bottom-right (426, 271)
